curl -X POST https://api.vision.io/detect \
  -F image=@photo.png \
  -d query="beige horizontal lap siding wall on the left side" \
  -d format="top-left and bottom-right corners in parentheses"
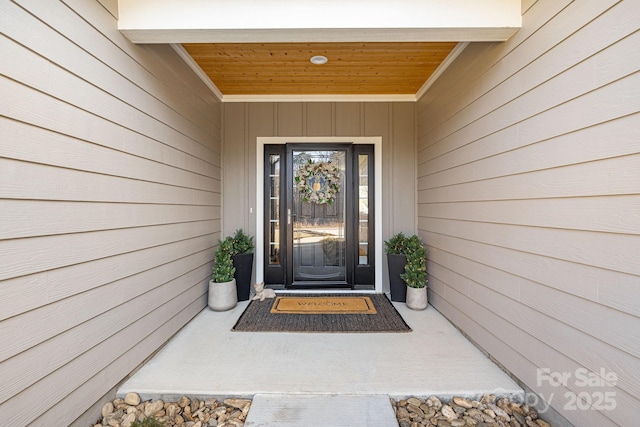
top-left (0, 0), bottom-right (221, 426)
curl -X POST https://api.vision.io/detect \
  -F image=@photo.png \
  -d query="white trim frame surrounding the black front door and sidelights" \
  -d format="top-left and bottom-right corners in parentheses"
top-left (255, 136), bottom-right (384, 293)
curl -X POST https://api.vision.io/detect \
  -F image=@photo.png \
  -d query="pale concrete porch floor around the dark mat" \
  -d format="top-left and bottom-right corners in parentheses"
top-left (117, 301), bottom-right (524, 400)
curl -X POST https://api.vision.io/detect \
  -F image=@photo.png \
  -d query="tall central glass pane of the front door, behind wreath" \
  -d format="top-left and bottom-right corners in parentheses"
top-left (291, 150), bottom-right (347, 282)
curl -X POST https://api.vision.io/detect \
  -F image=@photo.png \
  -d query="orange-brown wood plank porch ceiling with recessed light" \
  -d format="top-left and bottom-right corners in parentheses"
top-left (183, 42), bottom-right (457, 95)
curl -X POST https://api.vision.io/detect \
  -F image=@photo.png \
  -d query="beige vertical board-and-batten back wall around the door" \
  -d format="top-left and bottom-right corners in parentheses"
top-left (222, 102), bottom-right (416, 290)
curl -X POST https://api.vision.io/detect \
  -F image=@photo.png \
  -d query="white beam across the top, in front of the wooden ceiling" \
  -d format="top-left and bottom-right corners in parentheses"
top-left (118, 0), bottom-right (522, 43)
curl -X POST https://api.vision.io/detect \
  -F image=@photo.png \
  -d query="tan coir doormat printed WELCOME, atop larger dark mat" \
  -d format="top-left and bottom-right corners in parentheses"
top-left (271, 296), bottom-right (377, 314)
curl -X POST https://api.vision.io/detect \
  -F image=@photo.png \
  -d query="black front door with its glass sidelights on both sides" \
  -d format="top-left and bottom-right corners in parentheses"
top-left (264, 144), bottom-right (375, 290)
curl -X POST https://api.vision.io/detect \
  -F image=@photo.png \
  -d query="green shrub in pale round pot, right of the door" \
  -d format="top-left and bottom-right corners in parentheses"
top-left (400, 235), bottom-right (428, 310)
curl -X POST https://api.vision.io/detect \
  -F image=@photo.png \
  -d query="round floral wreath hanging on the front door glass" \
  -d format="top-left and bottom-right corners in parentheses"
top-left (295, 159), bottom-right (340, 205)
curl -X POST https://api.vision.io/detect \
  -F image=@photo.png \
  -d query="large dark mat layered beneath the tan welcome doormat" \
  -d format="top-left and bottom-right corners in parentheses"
top-left (232, 294), bottom-right (411, 333)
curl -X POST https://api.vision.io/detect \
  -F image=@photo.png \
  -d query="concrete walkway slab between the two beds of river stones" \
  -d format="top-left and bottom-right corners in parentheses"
top-left (244, 393), bottom-right (398, 427)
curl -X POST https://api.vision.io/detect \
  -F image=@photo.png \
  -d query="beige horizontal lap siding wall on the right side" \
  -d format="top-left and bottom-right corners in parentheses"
top-left (417, 0), bottom-right (640, 426)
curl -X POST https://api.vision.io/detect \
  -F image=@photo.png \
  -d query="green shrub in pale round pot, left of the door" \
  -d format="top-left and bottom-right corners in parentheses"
top-left (209, 238), bottom-right (238, 311)
